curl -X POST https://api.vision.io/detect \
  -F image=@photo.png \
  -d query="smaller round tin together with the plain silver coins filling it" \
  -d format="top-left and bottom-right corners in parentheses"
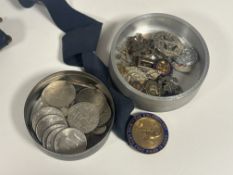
top-left (25, 71), bottom-right (115, 160)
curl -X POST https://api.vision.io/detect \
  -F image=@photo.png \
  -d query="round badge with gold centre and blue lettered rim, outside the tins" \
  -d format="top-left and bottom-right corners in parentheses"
top-left (126, 113), bottom-right (168, 154)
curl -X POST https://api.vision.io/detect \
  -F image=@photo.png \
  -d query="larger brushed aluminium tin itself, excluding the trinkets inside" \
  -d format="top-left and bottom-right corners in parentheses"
top-left (109, 13), bottom-right (209, 112)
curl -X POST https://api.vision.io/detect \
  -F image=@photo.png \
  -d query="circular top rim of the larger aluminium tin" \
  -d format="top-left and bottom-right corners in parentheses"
top-left (109, 13), bottom-right (210, 101)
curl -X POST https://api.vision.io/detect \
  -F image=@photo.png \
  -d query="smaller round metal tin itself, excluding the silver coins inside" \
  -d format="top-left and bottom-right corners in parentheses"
top-left (24, 71), bottom-right (115, 160)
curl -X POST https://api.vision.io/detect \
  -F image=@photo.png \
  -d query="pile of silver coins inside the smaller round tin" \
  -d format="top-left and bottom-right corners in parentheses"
top-left (31, 80), bottom-right (112, 154)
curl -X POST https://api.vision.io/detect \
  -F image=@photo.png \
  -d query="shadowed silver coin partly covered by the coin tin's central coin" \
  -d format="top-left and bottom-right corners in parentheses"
top-left (76, 88), bottom-right (107, 113)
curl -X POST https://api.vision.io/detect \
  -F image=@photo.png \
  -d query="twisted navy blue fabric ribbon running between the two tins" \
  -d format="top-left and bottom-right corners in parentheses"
top-left (19, 0), bottom-right (134, 139)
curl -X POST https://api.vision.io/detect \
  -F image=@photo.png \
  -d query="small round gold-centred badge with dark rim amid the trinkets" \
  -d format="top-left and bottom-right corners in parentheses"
top-left (154, 59), bottom-right (172, 76)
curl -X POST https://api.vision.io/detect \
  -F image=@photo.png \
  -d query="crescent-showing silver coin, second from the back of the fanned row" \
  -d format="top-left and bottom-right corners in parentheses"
top-left (36, 115), bottom-right (67, 142)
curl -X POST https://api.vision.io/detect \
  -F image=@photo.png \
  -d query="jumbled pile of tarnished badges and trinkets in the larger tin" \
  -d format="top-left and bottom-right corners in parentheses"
top-left (116, 31), bottom-right (198, 96)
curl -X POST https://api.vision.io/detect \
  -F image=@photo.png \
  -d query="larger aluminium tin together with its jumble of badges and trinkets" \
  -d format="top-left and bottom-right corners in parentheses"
top-left (109, 14), bottom-right (209, 112)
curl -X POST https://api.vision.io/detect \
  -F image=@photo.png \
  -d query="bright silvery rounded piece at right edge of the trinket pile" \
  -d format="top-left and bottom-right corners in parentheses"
top-left (172, 48), bottom-right (198, 72)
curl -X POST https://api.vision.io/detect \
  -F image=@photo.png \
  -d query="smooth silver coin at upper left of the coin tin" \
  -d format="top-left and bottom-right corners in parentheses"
top-left (42, 80), bottom-right (76, 108)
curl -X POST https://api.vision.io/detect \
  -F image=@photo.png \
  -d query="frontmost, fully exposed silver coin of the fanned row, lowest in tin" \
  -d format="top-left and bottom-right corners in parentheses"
top-left (54, 128), bottom-right (87, 154)
